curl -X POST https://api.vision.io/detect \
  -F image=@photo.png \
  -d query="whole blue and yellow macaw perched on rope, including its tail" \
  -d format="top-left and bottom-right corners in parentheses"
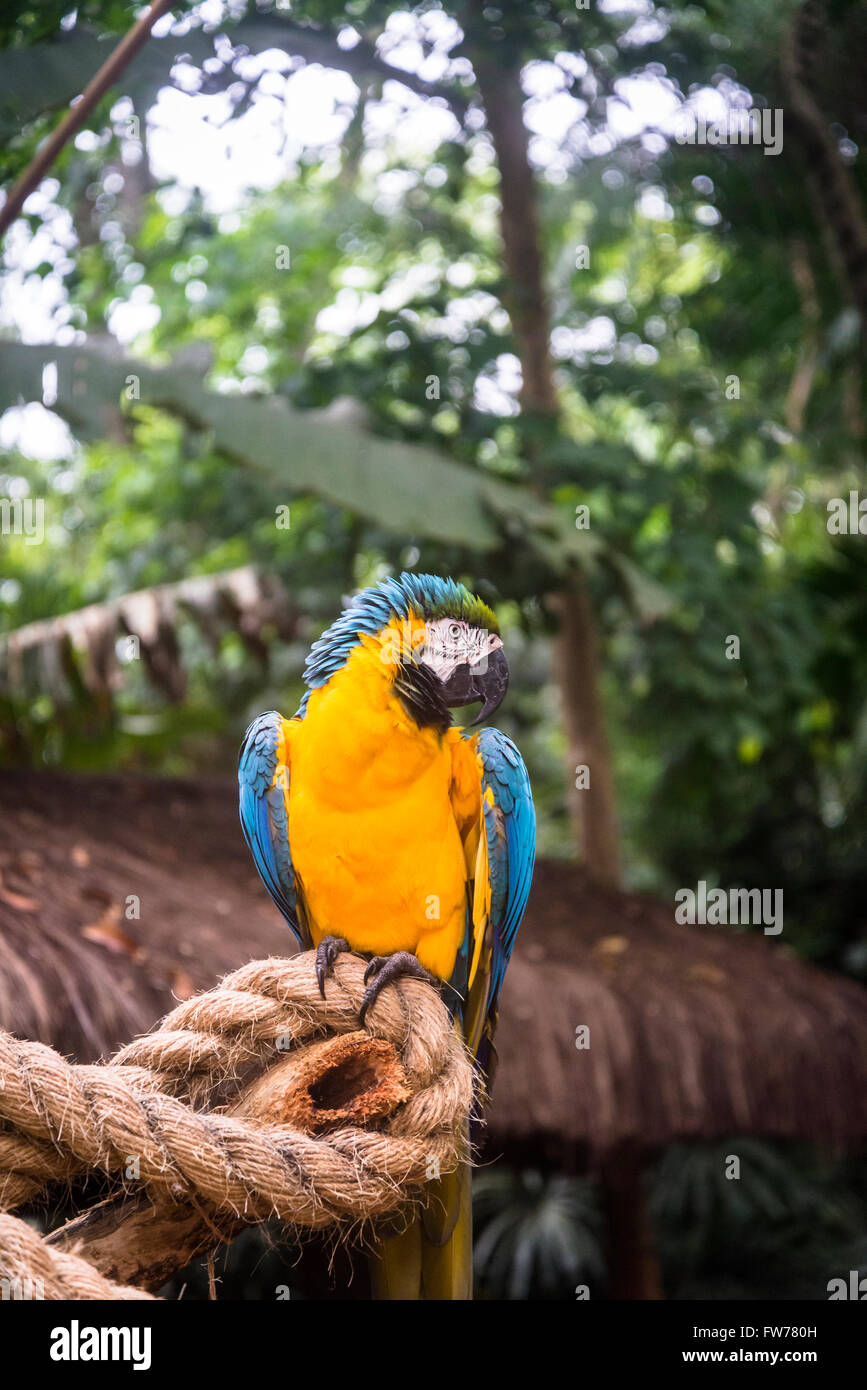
top-left (239, 574), bottom-right (536, 1298)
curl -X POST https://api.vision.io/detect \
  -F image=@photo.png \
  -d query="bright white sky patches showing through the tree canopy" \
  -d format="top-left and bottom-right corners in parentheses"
top-left (0, 0), bottom-right (745, 459)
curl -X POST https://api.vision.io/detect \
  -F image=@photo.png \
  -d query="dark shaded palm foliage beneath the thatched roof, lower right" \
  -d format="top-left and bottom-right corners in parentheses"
top-left (474, 1137), bottom-right (867, 1301)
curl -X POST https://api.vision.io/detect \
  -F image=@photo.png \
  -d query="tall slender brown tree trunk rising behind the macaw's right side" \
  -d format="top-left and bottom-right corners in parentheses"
top-left (464, 19), bottom-right (620, 885)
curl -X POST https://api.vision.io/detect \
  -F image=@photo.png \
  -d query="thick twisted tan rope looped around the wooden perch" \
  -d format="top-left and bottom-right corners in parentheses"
top-left (0, 952), bottom-right (472, 1298)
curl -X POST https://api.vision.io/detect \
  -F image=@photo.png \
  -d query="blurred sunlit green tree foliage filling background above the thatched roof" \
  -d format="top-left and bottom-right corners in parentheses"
top-left (0, 0), bottom-right (867, 950)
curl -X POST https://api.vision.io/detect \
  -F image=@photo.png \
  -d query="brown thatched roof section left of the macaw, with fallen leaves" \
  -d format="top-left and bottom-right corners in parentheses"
top-left (0, 771), bottom-right (279, 1061)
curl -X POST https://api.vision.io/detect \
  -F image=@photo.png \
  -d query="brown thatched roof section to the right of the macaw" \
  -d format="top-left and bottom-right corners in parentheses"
top-left (490, 862), bottom-right (867, 1165)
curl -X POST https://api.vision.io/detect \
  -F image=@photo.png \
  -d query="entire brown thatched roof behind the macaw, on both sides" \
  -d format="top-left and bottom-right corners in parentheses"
top-left (0, 771), bottom-right (867, 1165)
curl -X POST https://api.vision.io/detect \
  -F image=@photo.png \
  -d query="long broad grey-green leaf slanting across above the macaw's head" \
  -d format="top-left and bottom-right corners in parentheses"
top-left (0, 343), bottom-right (608, 570)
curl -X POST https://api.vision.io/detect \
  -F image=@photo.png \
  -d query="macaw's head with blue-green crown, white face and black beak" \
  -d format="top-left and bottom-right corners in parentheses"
top-left (304, 573), bottom-right (509, 724)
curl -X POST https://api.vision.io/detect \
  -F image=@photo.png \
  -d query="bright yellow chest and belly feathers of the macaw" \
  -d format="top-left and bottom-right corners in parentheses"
top-left (286, 631), bottom-right (481, 979)
